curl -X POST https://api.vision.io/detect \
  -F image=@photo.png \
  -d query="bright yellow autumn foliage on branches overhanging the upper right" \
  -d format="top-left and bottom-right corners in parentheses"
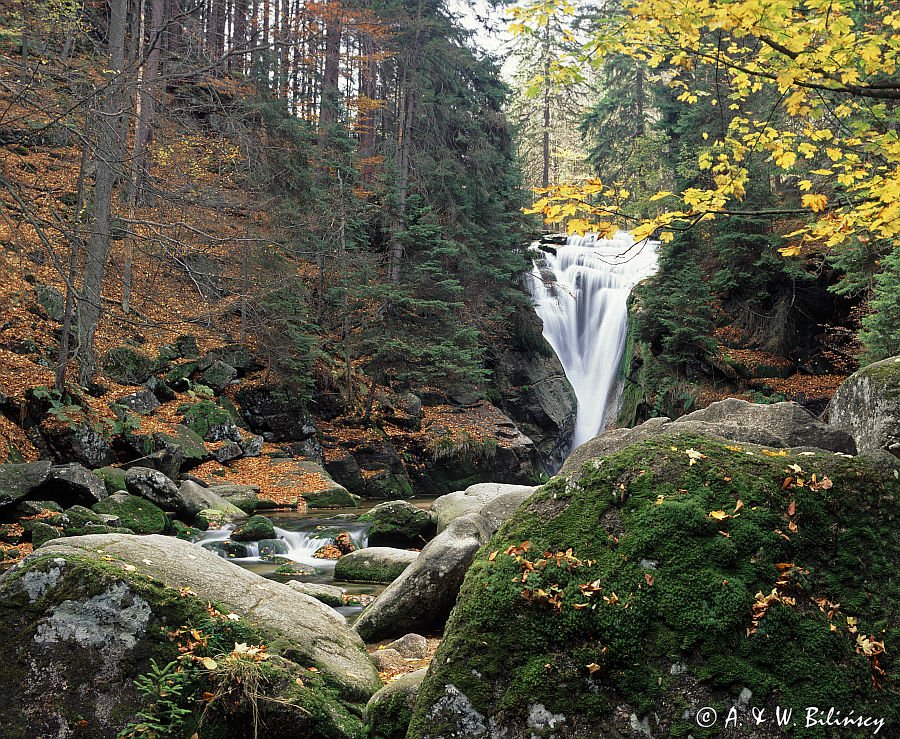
top-left (523, 0), bottom-right (900, 256)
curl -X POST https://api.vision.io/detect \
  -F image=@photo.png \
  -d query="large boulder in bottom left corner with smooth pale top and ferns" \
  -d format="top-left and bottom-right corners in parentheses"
top-left (0, 535), bottom-right (381, 739)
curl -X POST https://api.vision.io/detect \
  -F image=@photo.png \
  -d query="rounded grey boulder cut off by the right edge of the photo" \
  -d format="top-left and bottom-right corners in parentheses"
top-left (828, 356), bottom-right (900, 457)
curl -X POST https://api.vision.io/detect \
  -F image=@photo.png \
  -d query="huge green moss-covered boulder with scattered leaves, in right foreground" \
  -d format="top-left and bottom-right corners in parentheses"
top-left (408, 434), bottom-right (900, 739)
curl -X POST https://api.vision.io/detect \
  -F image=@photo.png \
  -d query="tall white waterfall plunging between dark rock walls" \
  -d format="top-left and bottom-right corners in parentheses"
top-left (529, 231), bottom-right (657, 449)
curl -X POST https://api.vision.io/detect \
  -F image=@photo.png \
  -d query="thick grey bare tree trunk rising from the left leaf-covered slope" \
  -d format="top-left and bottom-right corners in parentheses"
top-left (76, 0), bottom-right (128, 385)
